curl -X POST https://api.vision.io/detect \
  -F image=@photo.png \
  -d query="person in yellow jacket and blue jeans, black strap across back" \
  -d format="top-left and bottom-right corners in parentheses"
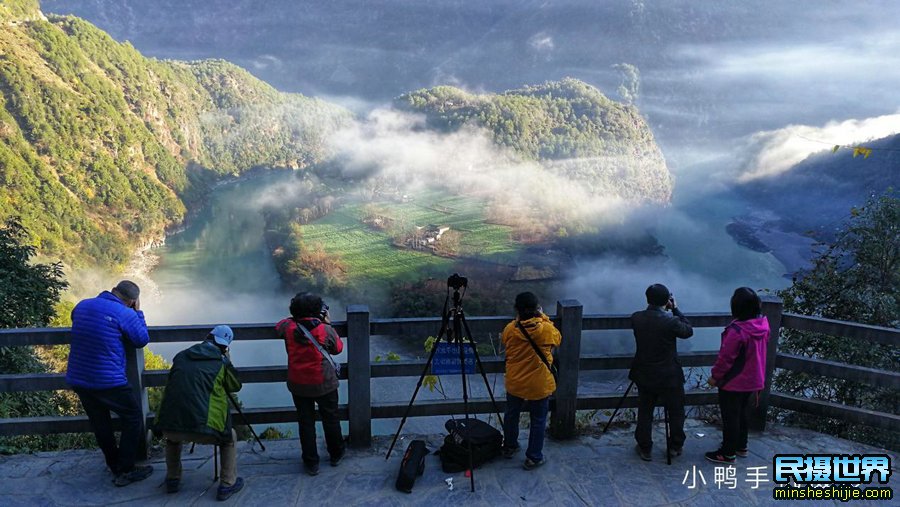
top-left (502, 292), bottom-right (562, 470)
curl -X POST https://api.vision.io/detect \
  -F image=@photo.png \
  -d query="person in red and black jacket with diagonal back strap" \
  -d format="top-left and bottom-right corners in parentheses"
top-left (275, 293), bottom-right (345, 475)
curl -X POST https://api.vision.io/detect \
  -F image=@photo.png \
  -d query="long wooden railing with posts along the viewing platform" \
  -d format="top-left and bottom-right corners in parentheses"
top-left (0, 300), bottom-right (900, 456)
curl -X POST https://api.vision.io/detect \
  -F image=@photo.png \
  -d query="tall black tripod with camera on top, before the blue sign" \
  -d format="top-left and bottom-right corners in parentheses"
top-left (384, 273), bottom-right (503, 492)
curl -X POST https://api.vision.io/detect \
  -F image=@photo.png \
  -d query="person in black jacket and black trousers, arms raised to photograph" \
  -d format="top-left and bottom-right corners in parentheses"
top-left (628, 284), bottom-right (694, 461)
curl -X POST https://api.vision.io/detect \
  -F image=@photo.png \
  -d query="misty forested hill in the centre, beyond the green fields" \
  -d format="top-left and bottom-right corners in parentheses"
top-left (394, 78), bottom-right (672, 203)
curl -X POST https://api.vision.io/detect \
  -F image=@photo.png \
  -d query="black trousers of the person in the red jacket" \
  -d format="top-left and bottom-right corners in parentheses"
top-left (293, 389), bottom-right (344, 465)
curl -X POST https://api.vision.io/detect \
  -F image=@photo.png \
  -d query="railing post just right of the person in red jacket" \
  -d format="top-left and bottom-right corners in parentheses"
top-left (347, 305), bottom-right (372, 447)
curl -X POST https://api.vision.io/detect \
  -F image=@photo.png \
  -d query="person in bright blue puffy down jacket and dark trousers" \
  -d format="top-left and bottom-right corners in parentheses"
top-left (66, 280), bottom-right (153, 486)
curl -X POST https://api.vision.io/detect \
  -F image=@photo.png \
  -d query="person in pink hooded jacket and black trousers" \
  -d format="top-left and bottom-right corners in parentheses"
top-left (706, 287), bottom-right (769, 464)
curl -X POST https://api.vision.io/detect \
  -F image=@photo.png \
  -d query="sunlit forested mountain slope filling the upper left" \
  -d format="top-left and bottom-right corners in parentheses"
top-left (0, 0), bottom-right (349, 266)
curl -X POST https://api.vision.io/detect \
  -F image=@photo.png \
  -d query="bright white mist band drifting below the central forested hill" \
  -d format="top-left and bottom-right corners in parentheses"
top-left (331, 109), bottom-right (664, 227)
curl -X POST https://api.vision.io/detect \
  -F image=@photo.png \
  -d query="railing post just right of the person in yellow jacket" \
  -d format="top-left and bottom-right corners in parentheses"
top-left (550, 299), bottom-right (584, 438)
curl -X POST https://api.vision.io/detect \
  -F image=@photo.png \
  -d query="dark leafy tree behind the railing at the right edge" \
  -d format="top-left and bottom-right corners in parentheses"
top-left (775, 191), bottom-right (900, 449)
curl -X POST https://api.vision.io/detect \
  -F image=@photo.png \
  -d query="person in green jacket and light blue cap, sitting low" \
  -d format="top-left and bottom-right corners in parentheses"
top-left (156, 325), bottom-right (244, 500)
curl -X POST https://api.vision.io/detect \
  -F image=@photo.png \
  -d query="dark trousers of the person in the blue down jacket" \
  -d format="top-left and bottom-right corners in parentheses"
top-left (74, 386), bottom-right (144, 474)
